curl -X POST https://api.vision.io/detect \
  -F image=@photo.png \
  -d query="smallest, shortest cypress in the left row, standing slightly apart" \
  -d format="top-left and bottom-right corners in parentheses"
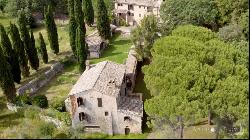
top-left (38, 32), bottom-right (48, 64)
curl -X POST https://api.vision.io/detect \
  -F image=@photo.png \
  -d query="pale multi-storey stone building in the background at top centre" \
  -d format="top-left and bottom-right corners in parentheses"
top-left (114, 0), bottom-right (165, 25)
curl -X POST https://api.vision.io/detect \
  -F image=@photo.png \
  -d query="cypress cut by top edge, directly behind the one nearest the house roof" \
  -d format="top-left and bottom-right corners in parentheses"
top-left (74, 0), bottom-right (86, 34)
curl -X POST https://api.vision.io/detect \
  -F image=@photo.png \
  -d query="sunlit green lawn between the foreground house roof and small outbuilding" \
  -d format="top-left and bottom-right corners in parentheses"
top-left (90, 34), bottom-right (132, 64)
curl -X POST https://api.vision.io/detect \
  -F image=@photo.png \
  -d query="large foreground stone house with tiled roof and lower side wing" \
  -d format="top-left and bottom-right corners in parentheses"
top-left (65, 61), bottom-right (143, 135)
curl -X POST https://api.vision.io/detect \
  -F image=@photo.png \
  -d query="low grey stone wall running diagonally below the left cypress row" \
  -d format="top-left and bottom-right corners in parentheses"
top-left (17, 62), bottom-right (63, 95)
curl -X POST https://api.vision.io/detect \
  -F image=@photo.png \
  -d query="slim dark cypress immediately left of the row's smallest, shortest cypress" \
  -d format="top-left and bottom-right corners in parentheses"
top-left (29, 30), bottom-right (39, 70)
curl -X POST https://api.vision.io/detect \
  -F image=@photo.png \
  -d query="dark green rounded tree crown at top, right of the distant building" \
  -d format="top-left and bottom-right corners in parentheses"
top-left (160, 0), bottom-right (219, 34)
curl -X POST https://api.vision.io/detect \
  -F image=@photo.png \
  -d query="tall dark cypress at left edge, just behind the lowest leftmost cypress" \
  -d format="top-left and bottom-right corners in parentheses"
top-left (0, 24), bottom-right (21, 84)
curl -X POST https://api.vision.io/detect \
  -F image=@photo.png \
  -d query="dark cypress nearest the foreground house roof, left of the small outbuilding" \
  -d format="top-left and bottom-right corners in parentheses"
top-left (76, 26), bottom-right (87, 72)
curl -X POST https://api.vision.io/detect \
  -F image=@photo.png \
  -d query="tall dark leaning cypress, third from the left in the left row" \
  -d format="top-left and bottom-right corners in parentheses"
top-left (10, 24), bottom-right (30, 77)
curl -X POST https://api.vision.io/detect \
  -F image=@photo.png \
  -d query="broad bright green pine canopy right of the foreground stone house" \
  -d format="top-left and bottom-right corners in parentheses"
top-left (143, 26), bottom-right (249, 138)
